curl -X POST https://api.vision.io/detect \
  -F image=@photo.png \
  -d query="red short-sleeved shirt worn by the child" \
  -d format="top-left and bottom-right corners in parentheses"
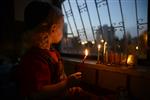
top-left (19, 48), bottom-right (59, 96)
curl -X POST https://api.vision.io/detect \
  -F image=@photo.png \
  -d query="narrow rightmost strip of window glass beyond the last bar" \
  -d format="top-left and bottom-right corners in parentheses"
top-left (137, 0), bottom-right (148, 59)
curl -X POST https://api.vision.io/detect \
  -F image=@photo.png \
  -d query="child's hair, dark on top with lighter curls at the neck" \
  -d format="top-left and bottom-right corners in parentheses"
top-left (24, 1), bottom-right (63, 47)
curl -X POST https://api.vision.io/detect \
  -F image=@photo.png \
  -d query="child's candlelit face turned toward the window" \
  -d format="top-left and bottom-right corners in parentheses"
top-left (50, 17), bottom-right (64, 43)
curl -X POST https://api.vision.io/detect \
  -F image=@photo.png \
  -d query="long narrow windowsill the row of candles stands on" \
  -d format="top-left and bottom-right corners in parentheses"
top-left (63, 57), bottom-right (150, 78)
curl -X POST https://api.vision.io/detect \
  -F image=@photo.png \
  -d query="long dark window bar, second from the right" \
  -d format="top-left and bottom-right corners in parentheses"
top-left (119, 0), bottom-right (127, 64)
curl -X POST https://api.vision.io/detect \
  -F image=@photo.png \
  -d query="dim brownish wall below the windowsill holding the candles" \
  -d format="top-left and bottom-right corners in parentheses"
top-left (64, 59), bottom-right (150, 100)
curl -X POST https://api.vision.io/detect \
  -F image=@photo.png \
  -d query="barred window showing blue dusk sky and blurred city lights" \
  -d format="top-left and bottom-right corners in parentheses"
top-left (61, 0), bottom-right (148, 64)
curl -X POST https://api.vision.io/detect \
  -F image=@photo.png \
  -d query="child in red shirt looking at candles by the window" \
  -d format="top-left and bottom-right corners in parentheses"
top-left (18, 1), bottom-right (81, 100)
